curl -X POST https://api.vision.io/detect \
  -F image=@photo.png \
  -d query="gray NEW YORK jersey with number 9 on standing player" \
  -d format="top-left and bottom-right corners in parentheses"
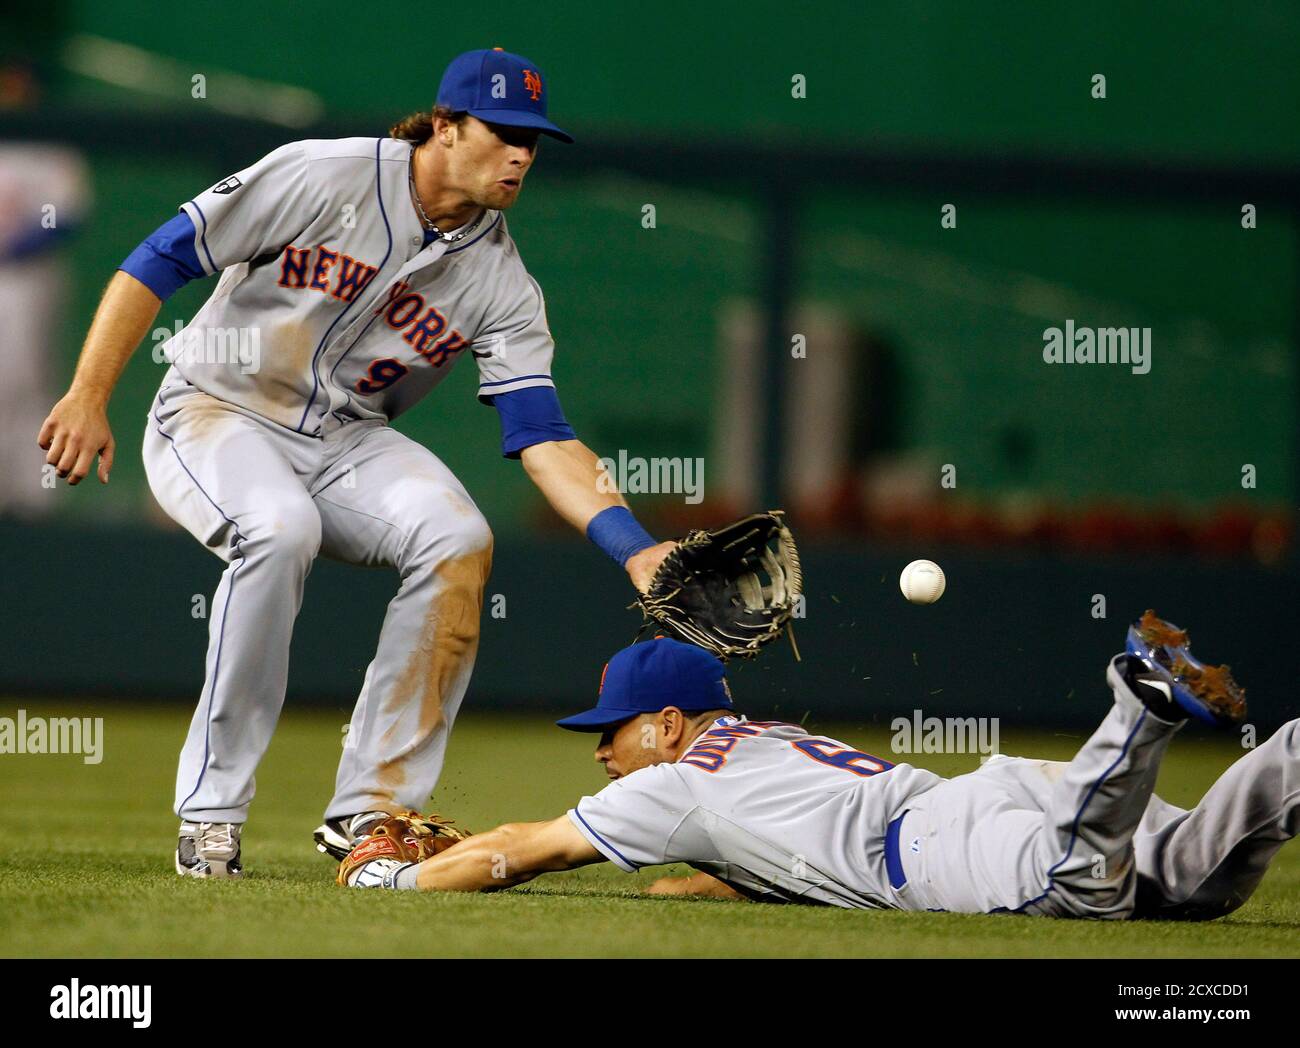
top-left (164, 138), bottom-right (554, 434)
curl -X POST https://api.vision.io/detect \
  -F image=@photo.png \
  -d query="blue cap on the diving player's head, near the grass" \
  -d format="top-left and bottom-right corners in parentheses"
top-left (555, 637), bottom-right (732, 732)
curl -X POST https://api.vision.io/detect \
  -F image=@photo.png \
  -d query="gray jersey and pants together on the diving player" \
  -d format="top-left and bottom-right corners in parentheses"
top-left (568, 657), bottom-right (1300, 919)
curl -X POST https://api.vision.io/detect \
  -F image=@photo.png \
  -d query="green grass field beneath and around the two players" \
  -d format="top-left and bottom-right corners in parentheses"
top-left (0, 701), bottom-right (1300, 958)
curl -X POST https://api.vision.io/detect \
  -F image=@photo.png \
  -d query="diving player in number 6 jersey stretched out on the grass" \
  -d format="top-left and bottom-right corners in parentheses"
top-left (339, 612), bottom-right (1300, 919)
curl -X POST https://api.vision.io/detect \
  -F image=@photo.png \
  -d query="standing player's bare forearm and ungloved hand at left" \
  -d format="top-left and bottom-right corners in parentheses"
top-left (36, 272), bottom-right (163, 484)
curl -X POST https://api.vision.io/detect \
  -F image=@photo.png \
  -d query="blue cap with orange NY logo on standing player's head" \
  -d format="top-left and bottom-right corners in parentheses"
top-left (437, 47), bottom-right (573, 142)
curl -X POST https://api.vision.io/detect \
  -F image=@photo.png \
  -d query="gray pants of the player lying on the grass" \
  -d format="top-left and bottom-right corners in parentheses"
top-left (896, 658), bottom-right (1300, 919)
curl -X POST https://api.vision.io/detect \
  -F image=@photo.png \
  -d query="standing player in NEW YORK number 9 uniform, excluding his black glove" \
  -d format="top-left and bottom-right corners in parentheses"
top-left (39, 48), bottom-right (672, 878)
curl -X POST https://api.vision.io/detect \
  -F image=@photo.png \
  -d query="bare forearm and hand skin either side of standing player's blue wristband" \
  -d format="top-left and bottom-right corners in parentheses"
top-left (520, 441), bottom-right (676, 593)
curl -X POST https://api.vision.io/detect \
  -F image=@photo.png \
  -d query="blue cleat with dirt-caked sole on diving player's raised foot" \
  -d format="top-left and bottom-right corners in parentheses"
top-left (1126, 609), bottom-right (1245, 727)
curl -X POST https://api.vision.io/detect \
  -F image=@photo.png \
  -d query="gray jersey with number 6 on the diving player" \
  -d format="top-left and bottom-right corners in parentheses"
top-left (568, 716), bottom-right (943, 908)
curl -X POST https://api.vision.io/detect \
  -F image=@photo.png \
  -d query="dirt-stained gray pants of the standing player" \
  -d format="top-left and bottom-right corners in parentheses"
top-left (144, 372), bottom-right (491, 823)
